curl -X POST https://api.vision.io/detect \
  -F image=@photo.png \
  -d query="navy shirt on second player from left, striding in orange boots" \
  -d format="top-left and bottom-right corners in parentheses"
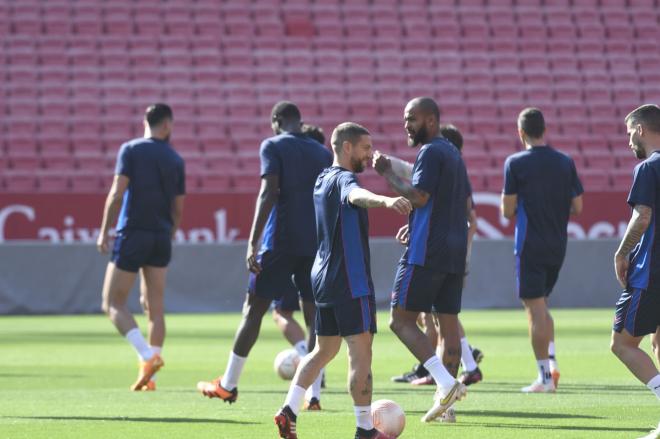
top-left (259, 133), bottom-right (332, 256)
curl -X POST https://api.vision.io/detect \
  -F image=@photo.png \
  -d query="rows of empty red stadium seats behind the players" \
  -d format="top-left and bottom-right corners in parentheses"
top-left (0, 0), bottom-right (660, 192)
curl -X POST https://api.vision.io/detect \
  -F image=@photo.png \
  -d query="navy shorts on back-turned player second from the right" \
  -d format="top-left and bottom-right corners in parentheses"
top-left (516, 256), bottom-right (561, 299)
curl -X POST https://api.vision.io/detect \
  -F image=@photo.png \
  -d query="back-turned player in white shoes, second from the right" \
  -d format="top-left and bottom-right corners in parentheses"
top-left (501, 108), bottom-right (584, 393)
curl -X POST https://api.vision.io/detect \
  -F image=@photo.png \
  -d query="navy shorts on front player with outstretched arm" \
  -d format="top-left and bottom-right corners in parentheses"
top-left (316, 295), bottom-right (376, 337)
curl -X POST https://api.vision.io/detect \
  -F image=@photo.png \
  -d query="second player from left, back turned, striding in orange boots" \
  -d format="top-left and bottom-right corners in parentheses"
top-left (197, 101), bottom-right (332, 409)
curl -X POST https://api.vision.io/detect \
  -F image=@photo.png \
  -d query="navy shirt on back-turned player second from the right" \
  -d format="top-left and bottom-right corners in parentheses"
top-left (504, 146), bottom-right (584, 265)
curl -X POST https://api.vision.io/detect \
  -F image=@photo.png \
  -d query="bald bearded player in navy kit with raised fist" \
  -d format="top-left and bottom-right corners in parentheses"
top-left (375, 97), bottom-right (469, 422)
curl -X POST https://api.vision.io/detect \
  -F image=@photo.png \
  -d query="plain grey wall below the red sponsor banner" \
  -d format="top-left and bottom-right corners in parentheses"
top-left (0, 239), bottom-right (619, 314)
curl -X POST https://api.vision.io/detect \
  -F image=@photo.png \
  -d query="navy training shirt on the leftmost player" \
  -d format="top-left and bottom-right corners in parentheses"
top-left (115, 138), bottom-right (186, 233)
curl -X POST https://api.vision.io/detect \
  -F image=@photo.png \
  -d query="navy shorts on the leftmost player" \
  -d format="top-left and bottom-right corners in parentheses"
top-left (111, 230), bottom-right (172, 273)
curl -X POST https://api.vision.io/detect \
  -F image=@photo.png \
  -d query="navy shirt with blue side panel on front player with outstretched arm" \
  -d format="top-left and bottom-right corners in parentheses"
top-left (312, 166), bottom-right (374, 307)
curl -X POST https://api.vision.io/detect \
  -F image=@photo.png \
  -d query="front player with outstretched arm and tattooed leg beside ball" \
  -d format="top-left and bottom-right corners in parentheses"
top-left (275, 122), bottom-right (412, 439)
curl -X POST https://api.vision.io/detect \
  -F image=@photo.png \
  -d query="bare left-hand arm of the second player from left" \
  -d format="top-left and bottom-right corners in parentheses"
top-left (245, 175), bottom-right (280, 274)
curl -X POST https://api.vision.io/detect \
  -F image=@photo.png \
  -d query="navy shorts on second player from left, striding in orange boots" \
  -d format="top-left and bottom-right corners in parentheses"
top-left (248, 250), bottom-right (314, 301)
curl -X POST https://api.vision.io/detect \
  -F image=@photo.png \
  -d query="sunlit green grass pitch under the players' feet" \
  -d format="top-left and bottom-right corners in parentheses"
top-left (0, 310), bottom-right (659, 439)
